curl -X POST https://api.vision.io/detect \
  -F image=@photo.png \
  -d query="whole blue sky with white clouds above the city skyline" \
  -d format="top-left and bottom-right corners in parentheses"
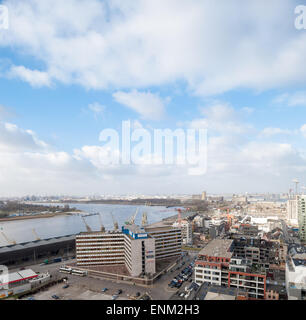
top-left (0, 0), bottom-right (306, 196)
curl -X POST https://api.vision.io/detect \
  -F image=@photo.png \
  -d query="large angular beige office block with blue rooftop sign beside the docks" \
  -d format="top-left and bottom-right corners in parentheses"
top-left (76, 224), bottom-right (182, 277)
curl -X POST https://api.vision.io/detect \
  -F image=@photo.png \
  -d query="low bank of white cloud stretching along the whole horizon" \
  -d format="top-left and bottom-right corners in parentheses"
top-left (0, 112), bottom-right (306, 195)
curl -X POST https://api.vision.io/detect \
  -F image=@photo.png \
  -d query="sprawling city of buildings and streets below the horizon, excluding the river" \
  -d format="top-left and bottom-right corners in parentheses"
top-left (0, 188), bottom-right (306, 301)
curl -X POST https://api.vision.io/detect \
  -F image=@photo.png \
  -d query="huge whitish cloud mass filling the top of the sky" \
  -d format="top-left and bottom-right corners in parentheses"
top-left (0, 0), bottom-right (306, 95)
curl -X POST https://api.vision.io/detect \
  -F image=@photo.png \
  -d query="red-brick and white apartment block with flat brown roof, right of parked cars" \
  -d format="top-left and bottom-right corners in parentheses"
top-left (195, 239), bottom-right (266, 299)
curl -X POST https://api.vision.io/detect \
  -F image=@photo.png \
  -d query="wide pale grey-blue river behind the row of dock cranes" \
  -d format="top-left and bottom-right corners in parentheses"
top-left (0, 203), bottom-right (177, 247)
